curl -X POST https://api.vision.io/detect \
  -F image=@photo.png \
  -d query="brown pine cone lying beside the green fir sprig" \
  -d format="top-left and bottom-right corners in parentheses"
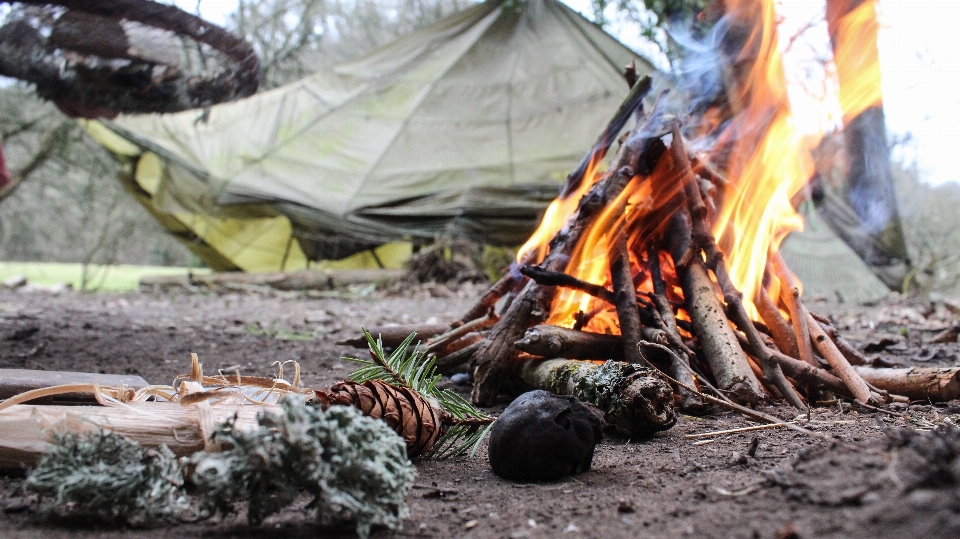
top-left (317, 380), bottom-right (451, 458)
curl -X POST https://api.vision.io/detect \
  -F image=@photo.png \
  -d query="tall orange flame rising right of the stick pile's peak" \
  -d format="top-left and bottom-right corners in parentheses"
top-left (714, 0), bottom-right (814, 315)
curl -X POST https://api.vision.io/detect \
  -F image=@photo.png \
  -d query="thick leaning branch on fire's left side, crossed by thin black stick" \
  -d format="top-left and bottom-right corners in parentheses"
top-left (471, 81), bottom-right (663, 405)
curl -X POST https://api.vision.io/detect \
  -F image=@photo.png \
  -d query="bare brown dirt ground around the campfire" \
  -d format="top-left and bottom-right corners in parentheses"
top-left (0, 286), bottom-right (960, 539)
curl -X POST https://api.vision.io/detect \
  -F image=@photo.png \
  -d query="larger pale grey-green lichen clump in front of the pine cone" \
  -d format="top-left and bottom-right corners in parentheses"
top-left (191, 397), bottom-right (416, 537)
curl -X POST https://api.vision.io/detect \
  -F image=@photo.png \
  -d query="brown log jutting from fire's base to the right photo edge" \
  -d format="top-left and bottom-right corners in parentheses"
top-left (854, 367), bottom-right (960, 402)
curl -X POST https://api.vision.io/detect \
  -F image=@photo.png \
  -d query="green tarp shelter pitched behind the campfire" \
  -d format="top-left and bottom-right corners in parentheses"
top-left (85, 0), bottom-right (654, 271)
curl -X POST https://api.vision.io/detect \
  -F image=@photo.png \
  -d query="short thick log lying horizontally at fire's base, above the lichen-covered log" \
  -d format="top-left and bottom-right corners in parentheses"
top-left (515, 324), bottom-right (623, 360)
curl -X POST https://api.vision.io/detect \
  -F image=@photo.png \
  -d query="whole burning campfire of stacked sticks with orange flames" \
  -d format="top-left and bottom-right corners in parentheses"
top-left (366, 0), bottom-right (952, 418)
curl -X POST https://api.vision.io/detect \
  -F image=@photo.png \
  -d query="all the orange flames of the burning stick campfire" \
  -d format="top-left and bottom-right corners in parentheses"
top-left (518, 0), bottom-right (880, 334)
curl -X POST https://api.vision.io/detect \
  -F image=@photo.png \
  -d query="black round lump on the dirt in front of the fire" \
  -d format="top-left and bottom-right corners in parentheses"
top-left (489, 389), bottom-right (603, 481)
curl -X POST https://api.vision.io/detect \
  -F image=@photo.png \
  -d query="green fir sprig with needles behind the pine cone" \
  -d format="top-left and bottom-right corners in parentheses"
top-left (343, 328), bottom-right (496, 460)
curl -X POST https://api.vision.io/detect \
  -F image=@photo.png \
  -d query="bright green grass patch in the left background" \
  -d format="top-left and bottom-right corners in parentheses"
top-left (0, 262), bottom-right (210, 292)
